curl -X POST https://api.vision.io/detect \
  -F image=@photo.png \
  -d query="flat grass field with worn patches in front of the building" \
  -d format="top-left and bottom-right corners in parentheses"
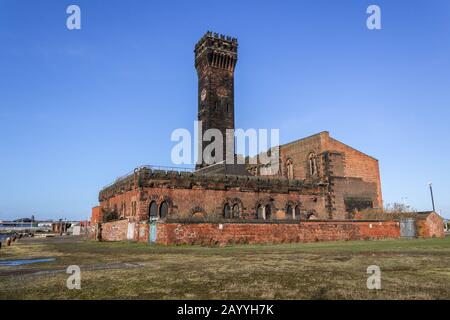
top-left (0, 237), bottom-right (450, 299)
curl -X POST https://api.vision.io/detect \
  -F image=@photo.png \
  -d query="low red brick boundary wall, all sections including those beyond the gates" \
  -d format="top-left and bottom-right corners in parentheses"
top-left (101, 213), bottom-right (445, 245)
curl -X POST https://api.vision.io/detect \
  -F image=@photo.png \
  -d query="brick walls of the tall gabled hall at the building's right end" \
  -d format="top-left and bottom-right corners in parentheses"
top-left (280, 131), bottom-right (383, 219)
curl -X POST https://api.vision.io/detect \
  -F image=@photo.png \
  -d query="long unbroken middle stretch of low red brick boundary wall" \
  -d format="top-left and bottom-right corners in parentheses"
top-left (157, 221), bottom-right (400, 245)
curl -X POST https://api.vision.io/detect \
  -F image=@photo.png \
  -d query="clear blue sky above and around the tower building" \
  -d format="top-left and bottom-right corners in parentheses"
top-left (0, 0), bottom-right (450, 219)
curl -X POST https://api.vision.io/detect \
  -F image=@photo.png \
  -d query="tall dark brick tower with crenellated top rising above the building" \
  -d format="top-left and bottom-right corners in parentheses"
top-left (194, 31), bottom-right (238, 169)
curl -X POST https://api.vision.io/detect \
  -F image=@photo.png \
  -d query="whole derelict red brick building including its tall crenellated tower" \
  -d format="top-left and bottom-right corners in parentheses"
top-left (92, 32), bottom-right (382, 223)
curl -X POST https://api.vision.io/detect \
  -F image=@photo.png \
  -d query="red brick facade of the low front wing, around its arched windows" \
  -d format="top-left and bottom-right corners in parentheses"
top-left (100, 182), bottom-right (328, 221)
